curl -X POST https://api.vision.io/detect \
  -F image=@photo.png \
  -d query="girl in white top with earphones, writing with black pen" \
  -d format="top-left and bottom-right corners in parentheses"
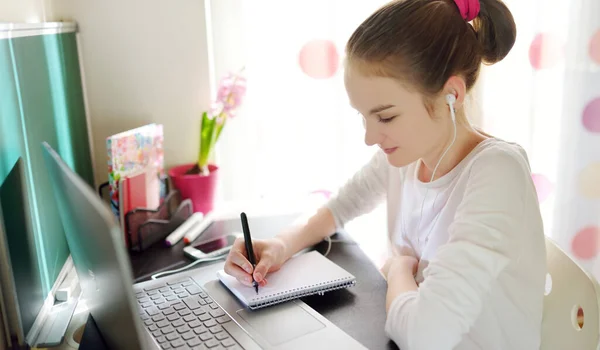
top-left (225, 0), bottom-right (546, 350)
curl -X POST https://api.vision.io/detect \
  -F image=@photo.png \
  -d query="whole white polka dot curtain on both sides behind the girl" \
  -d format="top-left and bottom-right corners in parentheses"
top-left (211, 0), bottom-right (600, 272)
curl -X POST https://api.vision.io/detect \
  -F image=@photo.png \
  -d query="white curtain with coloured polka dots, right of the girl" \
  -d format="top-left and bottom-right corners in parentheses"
top-left (481, 0), bottom-right (600, 279)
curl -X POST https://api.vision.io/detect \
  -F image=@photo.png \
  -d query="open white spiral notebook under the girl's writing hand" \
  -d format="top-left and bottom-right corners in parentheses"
top-left (217, 251), bottom-right (356, 310)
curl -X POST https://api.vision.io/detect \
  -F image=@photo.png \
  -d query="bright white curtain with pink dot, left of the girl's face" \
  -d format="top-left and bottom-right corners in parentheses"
top-left (230, 0), bottom-right (385, 197)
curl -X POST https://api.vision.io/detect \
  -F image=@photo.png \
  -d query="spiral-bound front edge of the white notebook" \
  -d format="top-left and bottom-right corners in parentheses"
top-left (248, 278), bottom-right (356, 310)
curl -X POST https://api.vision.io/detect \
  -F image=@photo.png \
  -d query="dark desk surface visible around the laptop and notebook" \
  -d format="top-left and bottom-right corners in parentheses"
top-left (80, 215), bottom-right (397, 350)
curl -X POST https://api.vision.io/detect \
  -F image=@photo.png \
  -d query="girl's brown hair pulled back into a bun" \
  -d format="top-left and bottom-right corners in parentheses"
top-left (346, 0), bottom-right (517, 104)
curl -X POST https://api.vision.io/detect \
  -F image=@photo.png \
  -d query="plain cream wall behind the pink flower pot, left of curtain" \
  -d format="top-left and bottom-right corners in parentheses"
top-left (49, 0), bottom-right (211, 187)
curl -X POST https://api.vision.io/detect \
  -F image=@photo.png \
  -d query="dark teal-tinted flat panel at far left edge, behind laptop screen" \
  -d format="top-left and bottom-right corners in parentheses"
top-left (0, 158), bottom-right (45, 346)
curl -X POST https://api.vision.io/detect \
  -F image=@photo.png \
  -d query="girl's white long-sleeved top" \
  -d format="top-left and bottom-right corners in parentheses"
top-left (328, 138), bottom-right (546, 350)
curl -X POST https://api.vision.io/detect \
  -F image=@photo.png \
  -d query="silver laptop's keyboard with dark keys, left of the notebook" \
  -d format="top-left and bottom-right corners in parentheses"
top-left (136, 278), bottom-right (242, 350)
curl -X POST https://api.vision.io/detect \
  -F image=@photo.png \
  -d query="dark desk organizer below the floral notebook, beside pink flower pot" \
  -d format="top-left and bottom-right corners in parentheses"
top-left (98, 178), bottom-right (194, 252)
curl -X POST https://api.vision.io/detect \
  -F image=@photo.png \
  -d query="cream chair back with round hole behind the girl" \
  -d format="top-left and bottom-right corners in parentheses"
top-left (541, 237), bottom-right (600, 350)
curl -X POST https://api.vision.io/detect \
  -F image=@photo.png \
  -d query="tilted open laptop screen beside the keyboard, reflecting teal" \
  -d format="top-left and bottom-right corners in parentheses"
top-left (43, 143), bottom-right (144, 350)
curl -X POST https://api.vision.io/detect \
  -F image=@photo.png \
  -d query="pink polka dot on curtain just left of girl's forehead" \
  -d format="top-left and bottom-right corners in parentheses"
top-left (298, 40), bottom-right (339, 79)
